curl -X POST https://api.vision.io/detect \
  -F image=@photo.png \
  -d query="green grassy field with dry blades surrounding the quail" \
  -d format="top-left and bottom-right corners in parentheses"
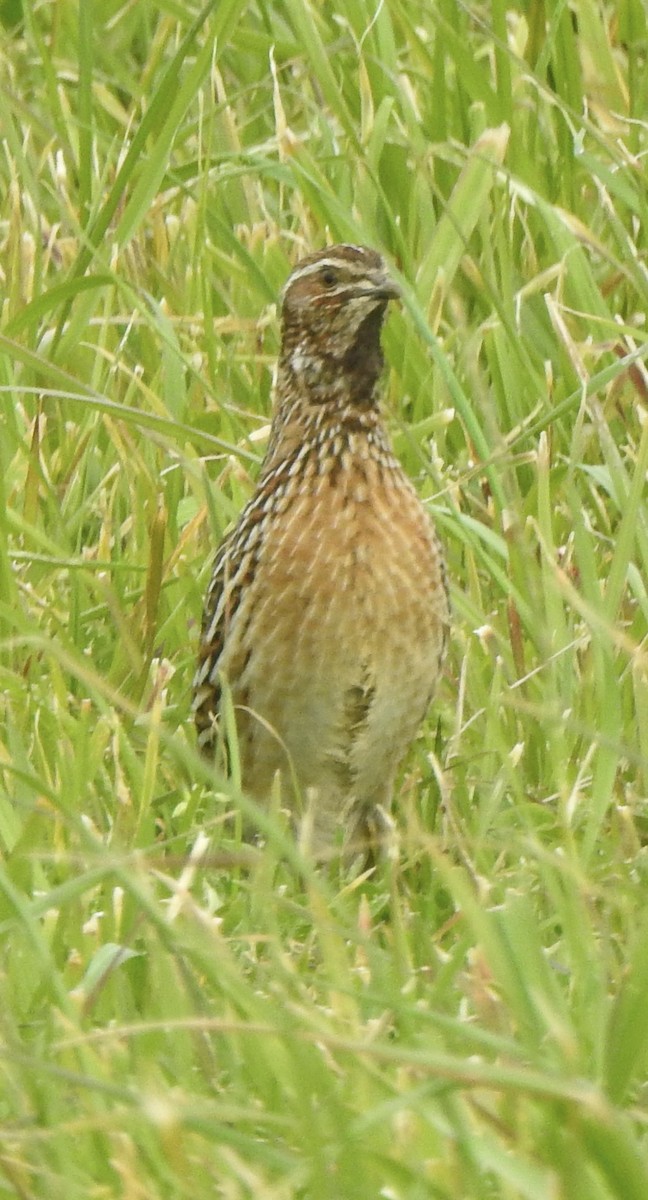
top-left (0, 0), bottom-right (648, 1200)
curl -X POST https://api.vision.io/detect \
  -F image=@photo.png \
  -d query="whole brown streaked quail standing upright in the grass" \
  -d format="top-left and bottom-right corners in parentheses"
top-left (189, 246), bottom-right (449, 853)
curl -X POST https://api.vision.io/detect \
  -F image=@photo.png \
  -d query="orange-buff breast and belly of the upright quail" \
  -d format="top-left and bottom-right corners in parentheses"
top-left (224, 477), bottom-right (445, 806)
